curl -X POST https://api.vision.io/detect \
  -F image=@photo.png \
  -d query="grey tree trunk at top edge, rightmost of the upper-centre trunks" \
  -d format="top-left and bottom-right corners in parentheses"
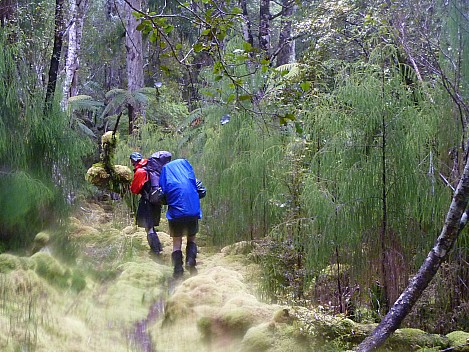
top-left (277, 0), bottom-right (296, 66)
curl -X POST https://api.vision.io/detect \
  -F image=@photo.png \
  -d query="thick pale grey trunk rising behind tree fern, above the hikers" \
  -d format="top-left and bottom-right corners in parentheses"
top-left (124, 0), bottom-right (144, 134)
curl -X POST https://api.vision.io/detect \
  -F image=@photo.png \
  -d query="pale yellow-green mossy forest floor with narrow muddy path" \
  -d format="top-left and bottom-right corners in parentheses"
top-left (0, 199), bottom-right (468, 352)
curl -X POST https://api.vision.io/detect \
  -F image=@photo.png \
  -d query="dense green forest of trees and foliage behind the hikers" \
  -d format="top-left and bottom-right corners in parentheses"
top-left (0, 0), bottom-right (469, 350)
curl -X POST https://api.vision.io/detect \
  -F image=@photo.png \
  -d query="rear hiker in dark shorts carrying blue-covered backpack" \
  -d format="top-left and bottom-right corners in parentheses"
top-left (160, 159), bottom-right (206, 278)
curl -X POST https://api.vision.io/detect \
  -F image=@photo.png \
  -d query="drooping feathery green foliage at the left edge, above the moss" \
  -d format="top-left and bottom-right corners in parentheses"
top-left (0, 32), bottom-right (90, 247)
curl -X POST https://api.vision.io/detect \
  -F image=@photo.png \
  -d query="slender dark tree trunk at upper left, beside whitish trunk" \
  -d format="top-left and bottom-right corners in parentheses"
top-left (45, 0), bottom-right (64, 110)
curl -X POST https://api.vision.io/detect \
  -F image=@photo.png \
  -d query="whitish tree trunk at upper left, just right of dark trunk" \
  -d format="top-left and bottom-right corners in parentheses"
top-left (62, 0), bottom-right (89, 110)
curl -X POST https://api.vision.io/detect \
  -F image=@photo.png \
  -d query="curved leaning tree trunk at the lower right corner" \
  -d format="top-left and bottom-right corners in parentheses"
top-left (357, 145), bottom-right (469, 352)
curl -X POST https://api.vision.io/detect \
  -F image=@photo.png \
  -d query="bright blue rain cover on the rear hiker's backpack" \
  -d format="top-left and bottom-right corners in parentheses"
top-left (160, 159), bottom-right (202, 221)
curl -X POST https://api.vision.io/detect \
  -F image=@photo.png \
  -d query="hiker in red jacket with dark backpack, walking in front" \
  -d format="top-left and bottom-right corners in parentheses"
top-left (130, 151), bottom-right (171, 254)
